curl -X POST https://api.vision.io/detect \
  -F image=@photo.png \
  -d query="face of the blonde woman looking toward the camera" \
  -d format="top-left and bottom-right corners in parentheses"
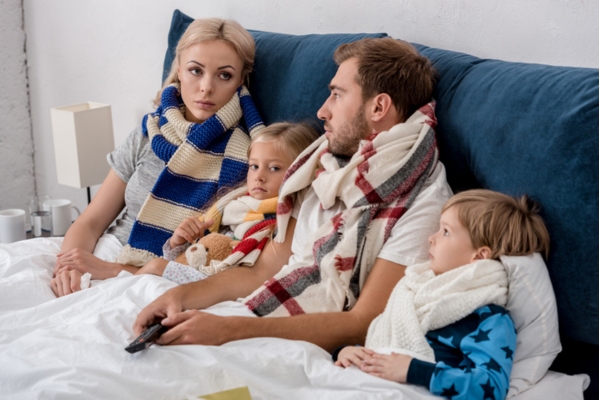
top-left (177, 40), bottom-right (244, 123)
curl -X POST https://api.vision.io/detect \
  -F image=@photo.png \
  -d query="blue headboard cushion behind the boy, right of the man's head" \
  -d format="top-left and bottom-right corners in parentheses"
top-left (417, 45), bottom-right (598, 344)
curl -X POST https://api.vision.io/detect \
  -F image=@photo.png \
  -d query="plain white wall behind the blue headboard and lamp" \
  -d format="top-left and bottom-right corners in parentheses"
top-left (18, 0), bottom-right (598, 212)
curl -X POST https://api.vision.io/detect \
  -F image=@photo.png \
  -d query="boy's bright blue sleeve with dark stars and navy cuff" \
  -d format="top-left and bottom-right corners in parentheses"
top-left (407, 311), bottom-right (517, 400)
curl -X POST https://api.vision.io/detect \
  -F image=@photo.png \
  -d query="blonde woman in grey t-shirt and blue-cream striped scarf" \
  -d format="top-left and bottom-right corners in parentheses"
top-left (51, 18), bottom-right (263, 296)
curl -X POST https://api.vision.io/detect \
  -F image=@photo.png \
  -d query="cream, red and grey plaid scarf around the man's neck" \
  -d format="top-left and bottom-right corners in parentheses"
top-left (244, 102), bottom-right (438, 316)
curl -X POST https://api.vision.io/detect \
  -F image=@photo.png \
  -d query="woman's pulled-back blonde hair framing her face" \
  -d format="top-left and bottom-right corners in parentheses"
top-left (154, 18), bottom-right (256, 106)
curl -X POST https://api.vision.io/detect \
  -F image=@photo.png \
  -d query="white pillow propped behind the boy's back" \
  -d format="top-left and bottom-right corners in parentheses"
top-left (500, 253), bottom-right (562, 398)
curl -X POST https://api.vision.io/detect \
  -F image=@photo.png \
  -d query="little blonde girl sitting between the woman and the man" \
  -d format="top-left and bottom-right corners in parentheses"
top-left (137, 122), bottom-right (319, 284)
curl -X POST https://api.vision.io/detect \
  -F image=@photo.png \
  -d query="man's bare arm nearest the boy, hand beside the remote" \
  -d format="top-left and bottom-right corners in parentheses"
top-left (152, 259), bottom-right (405, 351)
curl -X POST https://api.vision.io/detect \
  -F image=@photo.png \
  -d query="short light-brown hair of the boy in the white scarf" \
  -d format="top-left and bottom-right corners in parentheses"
top-left (442, 189), bottom-right (550, 260)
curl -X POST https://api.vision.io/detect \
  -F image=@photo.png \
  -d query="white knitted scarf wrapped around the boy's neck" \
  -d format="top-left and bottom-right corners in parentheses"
top-left (366, 260), bottom-right (508, 362)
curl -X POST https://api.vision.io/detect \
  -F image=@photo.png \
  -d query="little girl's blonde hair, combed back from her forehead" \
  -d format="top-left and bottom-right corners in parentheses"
top-left (248, 122), bottom-right (319, 160)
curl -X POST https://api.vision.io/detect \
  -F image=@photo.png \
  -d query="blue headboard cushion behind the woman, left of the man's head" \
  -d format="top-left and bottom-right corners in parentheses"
top-left (163, 10), bottom-right (387, 126)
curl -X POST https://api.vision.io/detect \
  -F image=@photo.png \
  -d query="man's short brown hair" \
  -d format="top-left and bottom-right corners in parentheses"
top-left (333, 38), bottom-right (436, 122)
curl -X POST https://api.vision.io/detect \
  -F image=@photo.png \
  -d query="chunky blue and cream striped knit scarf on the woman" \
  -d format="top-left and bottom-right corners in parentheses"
top-left (116, 84), bottom-right (263, 266)
